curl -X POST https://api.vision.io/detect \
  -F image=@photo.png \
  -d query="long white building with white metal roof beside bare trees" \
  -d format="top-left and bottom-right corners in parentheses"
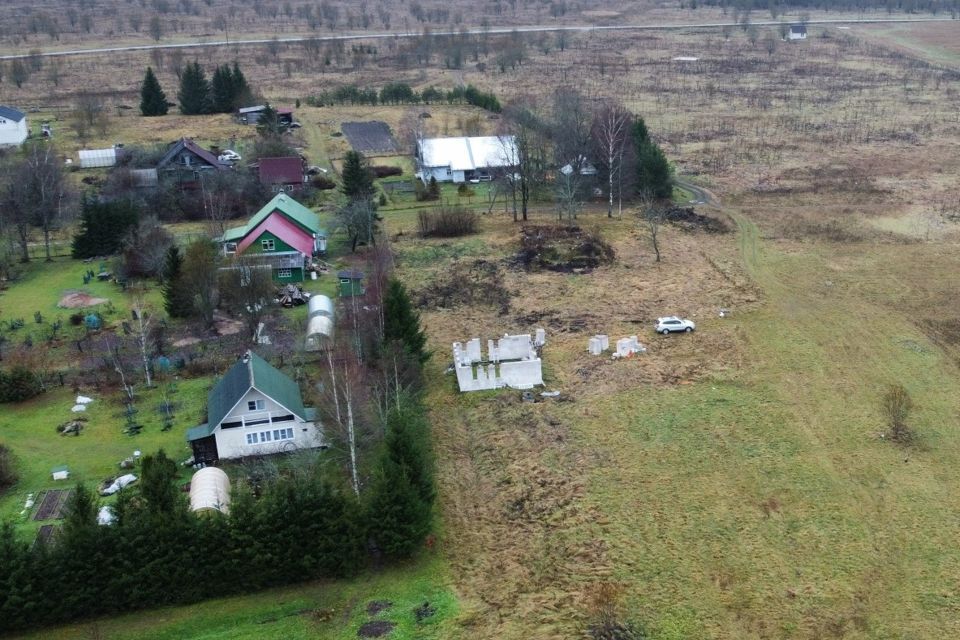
top-left (417, 136), bottom-right (517, 183)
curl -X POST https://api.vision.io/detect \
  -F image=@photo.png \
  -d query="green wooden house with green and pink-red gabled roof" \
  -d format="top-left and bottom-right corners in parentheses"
top-left (220, 193), bottom-right (327, 282)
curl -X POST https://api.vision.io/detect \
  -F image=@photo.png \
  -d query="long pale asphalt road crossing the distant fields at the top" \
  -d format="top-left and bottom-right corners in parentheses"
top-left (0, 18), bottom-right (957, 60)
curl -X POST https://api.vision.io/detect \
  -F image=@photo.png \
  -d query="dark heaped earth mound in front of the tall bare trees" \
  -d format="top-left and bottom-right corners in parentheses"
top-left (514, 225), bottom-right (616, 273)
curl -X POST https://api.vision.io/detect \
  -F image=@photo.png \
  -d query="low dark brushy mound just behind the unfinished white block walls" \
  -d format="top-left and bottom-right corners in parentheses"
top-left (414, 260), bottom-right (510, 315)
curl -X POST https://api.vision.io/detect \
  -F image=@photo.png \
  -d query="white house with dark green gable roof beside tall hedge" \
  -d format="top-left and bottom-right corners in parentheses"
top-left (187, 351), bottom-right (326, 464)
